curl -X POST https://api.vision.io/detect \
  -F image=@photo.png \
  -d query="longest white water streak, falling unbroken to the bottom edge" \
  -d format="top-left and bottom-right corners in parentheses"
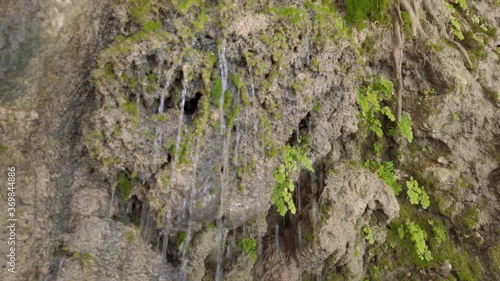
top-left (215, 39), bottom-right (229, 281)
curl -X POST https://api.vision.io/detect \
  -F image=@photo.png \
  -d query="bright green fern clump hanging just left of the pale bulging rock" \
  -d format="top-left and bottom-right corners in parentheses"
top-left (272, 145), bottom-right (313, 216)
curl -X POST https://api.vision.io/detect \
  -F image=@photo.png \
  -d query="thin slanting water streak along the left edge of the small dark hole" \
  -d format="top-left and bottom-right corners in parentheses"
top-left (162, 80), bottom-right (188, 264)
